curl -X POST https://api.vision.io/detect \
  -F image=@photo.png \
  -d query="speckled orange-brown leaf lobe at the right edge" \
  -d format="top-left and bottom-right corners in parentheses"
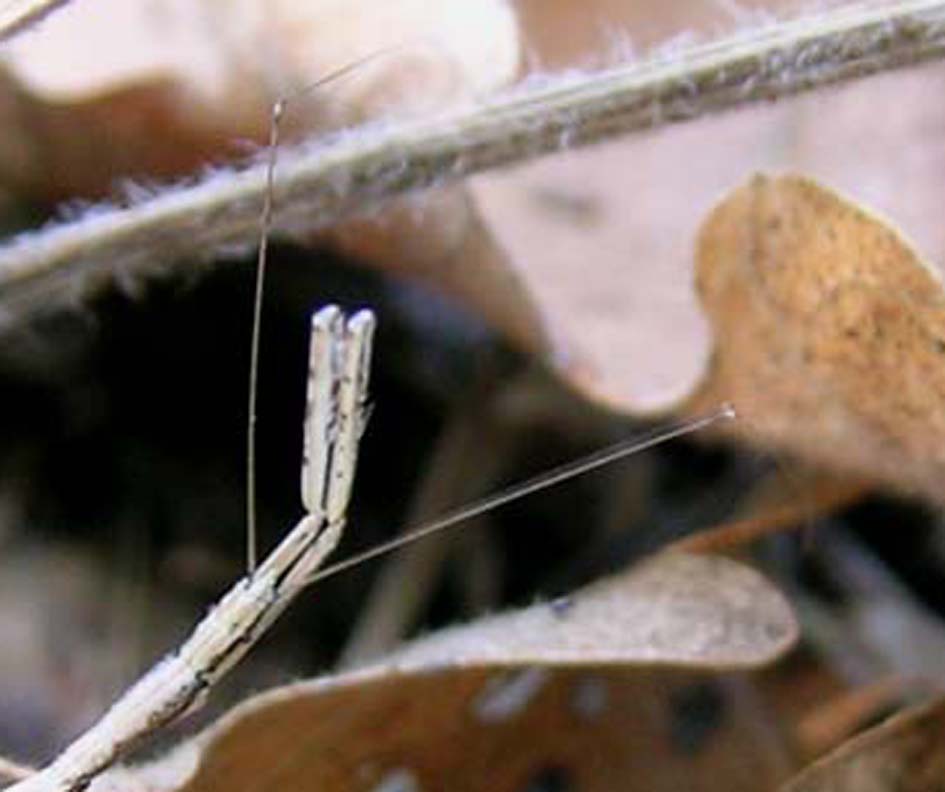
top-left (694, 176), bottom-right (945, 500)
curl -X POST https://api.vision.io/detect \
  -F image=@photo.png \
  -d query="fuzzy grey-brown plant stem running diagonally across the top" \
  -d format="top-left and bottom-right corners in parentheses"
top-left (0, 0), bottom-right (945, 328)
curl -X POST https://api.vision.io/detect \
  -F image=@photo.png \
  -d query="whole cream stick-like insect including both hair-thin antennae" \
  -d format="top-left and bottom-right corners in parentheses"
top-left (3, 60), bottom-right (734, 792)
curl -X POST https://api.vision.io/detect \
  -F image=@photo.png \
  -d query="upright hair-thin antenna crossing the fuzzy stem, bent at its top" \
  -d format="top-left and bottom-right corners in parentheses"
top-left (246, 47), bottom-right (412, 575)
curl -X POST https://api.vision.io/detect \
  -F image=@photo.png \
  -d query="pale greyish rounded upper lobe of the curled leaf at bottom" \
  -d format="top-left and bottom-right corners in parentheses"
top-left (394, 553), bottom-right (797, 668)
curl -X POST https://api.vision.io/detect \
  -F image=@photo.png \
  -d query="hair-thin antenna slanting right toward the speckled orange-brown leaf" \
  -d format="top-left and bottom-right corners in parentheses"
top-left (306, 404), bottom-right (736, 584)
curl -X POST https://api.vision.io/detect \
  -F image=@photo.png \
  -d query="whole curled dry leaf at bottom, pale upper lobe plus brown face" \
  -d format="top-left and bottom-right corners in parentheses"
top-left (94, 554), bottom-right (796, 790)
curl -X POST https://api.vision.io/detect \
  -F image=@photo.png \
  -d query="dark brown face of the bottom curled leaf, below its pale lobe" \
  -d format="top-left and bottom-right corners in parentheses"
top-left (166, 668), bottom-right (792, 792)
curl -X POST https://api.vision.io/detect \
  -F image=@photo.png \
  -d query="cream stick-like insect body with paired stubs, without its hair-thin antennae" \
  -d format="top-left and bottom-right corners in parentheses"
top-left (15, 306), bottom-right (374, 790)
